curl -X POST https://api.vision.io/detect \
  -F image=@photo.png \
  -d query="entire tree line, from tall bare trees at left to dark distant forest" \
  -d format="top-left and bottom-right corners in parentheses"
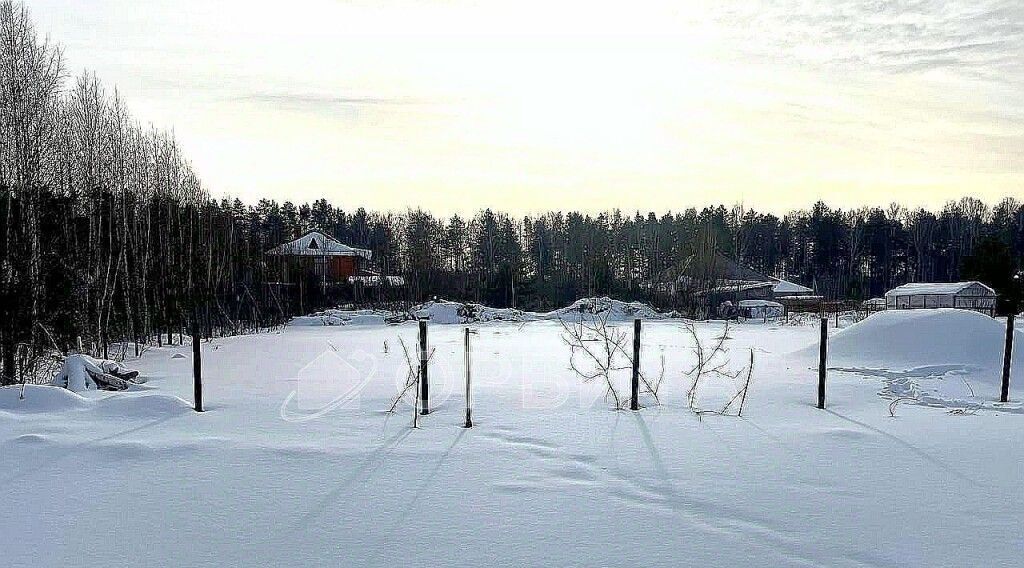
top-left (0, 0), bottom-right (1024, 383)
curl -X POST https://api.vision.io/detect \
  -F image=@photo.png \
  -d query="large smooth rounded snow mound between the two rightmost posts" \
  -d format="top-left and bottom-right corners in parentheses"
top-left (804, 308), bottom-right (1024, 381)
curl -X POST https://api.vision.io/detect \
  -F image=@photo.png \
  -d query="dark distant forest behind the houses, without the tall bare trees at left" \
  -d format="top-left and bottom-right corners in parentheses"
top-left (282, 198), bottom-right (1024, 311)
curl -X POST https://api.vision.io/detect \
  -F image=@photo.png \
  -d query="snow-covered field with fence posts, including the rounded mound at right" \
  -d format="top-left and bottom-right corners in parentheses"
top-left (0, 310), bottom-right (1024, 567)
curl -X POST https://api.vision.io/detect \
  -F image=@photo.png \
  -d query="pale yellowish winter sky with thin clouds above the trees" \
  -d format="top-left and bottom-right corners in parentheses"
top-left (26, 0), bottom-right (1024, 214)
